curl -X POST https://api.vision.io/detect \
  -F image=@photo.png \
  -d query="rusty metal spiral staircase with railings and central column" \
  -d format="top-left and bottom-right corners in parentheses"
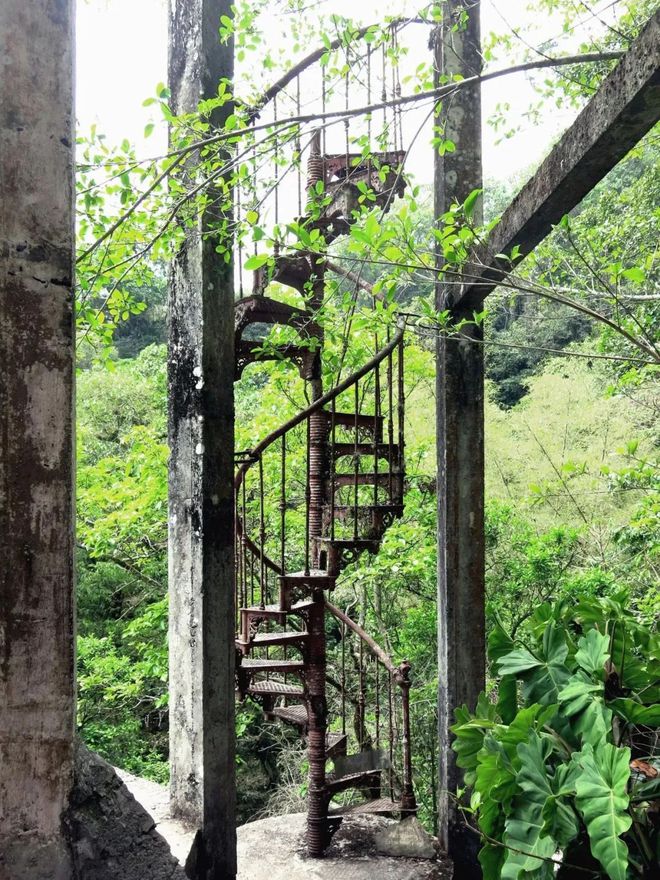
top-left (235, 141), bottom-right (416, 857)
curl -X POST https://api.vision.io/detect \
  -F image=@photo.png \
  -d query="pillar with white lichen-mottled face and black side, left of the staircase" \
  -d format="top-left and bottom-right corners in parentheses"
top-left (168, 0), bottom-right (236, 880)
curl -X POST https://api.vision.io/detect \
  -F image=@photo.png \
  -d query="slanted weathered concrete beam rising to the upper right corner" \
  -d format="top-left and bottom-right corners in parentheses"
top-left (449, 11), bottom-right (660, 314)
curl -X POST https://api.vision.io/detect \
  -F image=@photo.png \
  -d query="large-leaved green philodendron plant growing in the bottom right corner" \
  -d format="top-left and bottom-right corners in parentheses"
top-left (452, 596), bottom-right (660, 880)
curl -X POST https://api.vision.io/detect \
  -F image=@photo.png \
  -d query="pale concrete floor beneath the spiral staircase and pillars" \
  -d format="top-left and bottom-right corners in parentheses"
top-left (117, 770), bottom-right (453, 880)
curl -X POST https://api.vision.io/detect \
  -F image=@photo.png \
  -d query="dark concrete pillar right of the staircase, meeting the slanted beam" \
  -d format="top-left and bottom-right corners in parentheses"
top-left (435, 0), bottom-right (485, 880)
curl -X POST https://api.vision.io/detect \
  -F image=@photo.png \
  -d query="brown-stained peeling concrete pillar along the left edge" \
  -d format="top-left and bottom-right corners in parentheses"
top-left (0, 0), bottom-right (75, 880)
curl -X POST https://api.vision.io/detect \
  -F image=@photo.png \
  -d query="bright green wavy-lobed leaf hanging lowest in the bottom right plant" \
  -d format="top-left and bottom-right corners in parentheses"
top-left (573, 743), bottom-right (632, 880)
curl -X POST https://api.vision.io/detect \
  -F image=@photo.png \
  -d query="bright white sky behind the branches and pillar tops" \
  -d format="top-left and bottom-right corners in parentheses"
top-left (77, 0), bottom-right (608, 182)
